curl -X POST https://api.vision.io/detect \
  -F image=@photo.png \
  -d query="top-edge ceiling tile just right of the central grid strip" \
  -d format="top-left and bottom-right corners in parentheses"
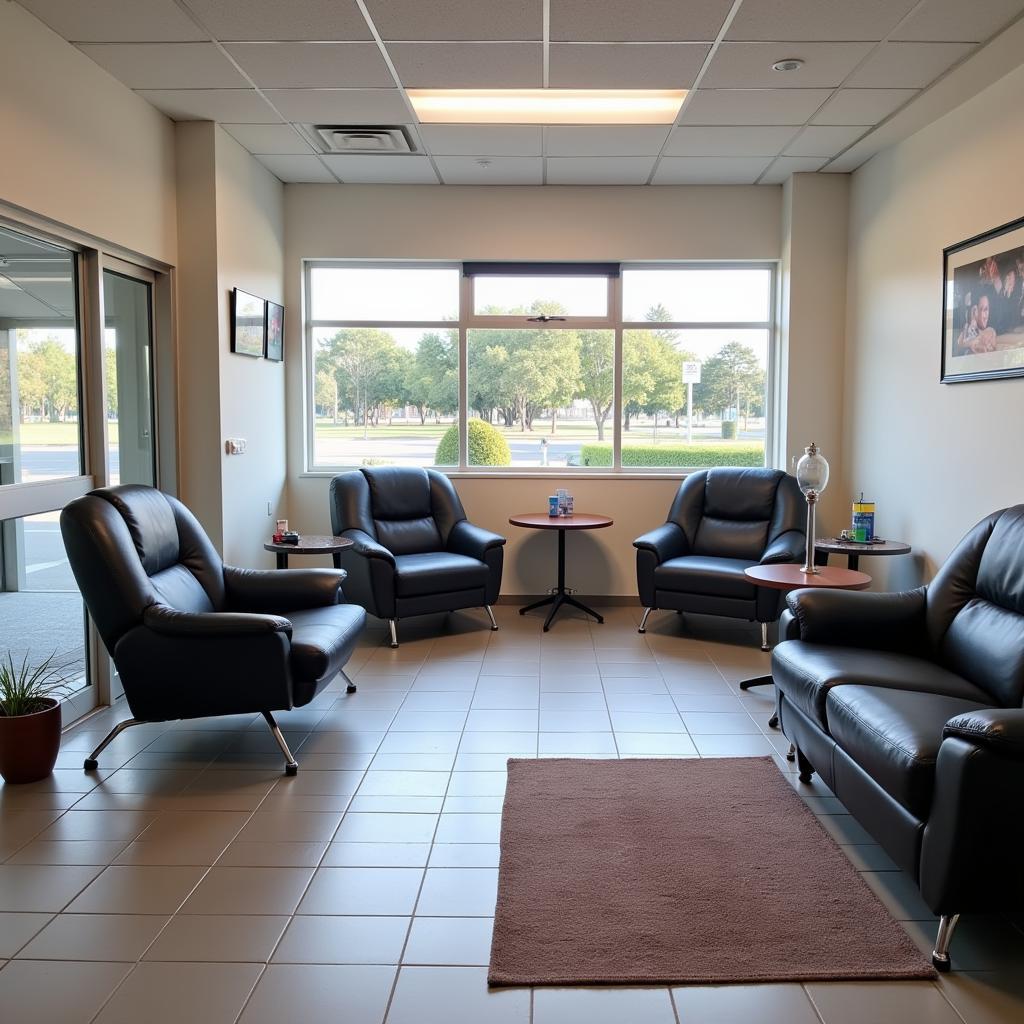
top-left (551, 0), bottom-right (732, 42)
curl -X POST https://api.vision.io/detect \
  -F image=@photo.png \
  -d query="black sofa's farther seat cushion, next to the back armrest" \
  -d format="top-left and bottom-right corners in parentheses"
top-left (771, 640), bottom-right (992, 731)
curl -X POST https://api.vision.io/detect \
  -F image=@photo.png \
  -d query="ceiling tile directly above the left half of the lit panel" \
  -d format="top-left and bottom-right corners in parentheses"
top-left (388, 43), bottom-right (544, 89)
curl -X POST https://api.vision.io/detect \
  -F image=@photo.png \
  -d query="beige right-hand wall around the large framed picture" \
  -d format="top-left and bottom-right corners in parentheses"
top-left (844, 61), bottom-right (1024, 588)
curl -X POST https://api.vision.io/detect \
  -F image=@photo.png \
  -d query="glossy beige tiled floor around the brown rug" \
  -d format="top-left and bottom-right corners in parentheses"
top-left (0, 606), bottom-right (1024, 1024)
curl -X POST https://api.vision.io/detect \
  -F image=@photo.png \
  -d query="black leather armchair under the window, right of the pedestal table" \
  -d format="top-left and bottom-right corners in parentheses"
top-left (633, 468), bottom-right (807, 650)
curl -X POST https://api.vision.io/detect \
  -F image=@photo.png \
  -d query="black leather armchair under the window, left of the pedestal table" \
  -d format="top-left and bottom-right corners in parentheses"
top-left (331, 466), bottom-right (505, 647)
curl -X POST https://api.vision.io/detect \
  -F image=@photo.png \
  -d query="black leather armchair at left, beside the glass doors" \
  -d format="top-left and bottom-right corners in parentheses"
top-left (60, 485), bottom-right (367, 775)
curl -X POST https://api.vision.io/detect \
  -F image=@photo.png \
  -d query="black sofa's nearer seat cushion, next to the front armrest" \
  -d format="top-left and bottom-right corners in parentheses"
top-left (825, 686), bottom-right (983, 820)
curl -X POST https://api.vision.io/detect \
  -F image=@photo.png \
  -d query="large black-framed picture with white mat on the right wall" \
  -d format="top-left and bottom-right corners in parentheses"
top-left (941, 217), bottom-right (1024, 384)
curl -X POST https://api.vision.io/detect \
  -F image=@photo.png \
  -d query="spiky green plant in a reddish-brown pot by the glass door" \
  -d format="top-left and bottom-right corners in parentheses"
top-left (0, 652), bottom-right (67, 782)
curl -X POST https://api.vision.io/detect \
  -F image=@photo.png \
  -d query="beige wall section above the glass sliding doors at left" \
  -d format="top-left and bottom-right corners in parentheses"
top-left (0, 3), bottom-right (177, 264)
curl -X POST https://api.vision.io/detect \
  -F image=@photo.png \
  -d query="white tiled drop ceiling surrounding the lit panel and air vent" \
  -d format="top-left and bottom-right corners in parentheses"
top-left (19, 0), bottom-right (1024, 185)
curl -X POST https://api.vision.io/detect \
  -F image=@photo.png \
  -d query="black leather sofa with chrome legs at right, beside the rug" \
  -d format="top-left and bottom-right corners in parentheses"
top-left (772, 505), bottom-right (1024, 971)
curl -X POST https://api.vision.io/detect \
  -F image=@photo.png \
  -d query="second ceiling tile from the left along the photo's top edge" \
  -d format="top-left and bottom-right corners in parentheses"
top-left (187, 0), bottom-right (373, 42)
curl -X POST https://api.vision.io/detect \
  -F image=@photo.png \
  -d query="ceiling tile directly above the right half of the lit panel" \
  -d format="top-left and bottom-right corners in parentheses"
top-left (549, 43), bottom-right (711, 89)
